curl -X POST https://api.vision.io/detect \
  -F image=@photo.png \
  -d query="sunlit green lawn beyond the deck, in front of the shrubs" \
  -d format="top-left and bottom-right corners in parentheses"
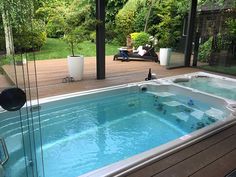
top-left (0, 38), bottom-right (119, 65)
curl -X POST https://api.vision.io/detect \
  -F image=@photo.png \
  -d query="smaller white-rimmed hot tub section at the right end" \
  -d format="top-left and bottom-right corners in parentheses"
top-left (162, 72), bottom-right (236, 101)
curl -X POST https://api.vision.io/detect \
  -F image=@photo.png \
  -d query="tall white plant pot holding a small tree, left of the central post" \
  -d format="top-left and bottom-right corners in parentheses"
top-left (67, 56), bottom-right (84, 81)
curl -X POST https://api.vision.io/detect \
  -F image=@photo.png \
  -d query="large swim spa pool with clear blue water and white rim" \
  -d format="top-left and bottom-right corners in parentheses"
top-left (0, 81), bottom-right (236, 177)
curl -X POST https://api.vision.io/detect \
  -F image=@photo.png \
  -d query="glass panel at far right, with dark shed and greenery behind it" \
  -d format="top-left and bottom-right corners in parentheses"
top-left (196, 1), bottom-right (236, 70)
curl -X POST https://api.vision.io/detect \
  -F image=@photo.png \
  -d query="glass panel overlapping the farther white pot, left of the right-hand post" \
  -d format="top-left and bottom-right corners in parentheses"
top-left (159, 1), bottom-right (190, 69)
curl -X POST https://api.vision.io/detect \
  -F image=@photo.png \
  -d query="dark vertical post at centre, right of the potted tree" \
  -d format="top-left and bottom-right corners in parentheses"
top-left (96, 0), bottom-right (105, 79)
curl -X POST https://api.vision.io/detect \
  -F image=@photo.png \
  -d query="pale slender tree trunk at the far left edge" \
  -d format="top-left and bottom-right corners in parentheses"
top-left (2, 10), bottom-right (15, 55)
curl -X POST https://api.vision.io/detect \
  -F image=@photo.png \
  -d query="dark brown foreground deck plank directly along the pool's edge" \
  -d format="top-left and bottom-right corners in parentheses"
top-left (127, 125), bottom-right (236, 177)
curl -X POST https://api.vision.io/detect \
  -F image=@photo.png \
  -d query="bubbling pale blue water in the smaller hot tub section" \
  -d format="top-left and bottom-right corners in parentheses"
top-left (178, 77), bottom-right (236, 100)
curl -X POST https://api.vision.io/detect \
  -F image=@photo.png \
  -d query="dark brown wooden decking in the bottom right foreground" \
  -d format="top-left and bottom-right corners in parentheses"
top-left (124, 125), bottom-right (236, 177)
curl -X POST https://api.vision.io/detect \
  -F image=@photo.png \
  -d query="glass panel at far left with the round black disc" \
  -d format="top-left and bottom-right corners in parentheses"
top-left (0, 0), bottom-right (43, 177)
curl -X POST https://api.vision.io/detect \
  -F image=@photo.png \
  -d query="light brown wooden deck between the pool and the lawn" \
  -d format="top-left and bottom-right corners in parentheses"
top-left (3, 56), bottom-right (199, 98)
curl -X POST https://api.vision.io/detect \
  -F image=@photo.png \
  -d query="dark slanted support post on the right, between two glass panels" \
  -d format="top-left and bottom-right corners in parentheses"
top-left (184, 0), bottom-right (197, 67)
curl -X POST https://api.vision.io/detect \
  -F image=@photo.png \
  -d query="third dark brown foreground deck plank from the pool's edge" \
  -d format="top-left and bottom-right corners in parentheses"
top-left (190, 149), bottom-right (236, 177)
